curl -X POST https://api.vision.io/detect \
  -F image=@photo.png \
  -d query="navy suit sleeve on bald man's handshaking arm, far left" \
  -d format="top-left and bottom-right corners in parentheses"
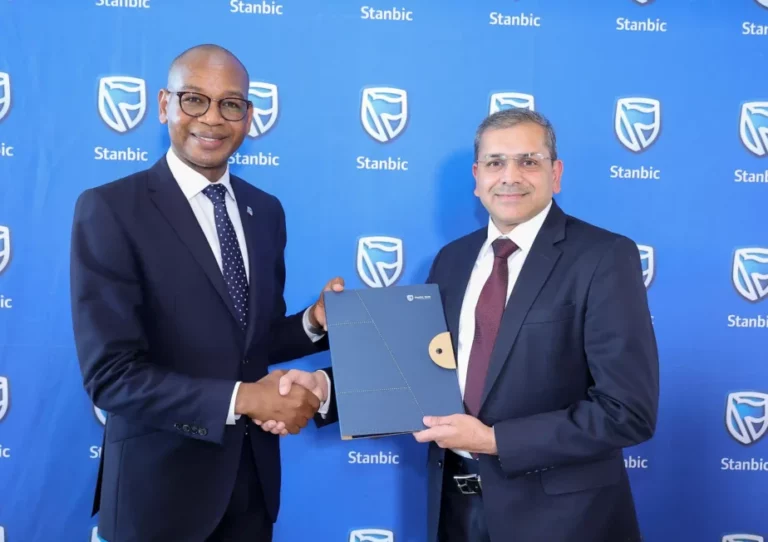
top-left (70, 190), bottom-right (235, 443)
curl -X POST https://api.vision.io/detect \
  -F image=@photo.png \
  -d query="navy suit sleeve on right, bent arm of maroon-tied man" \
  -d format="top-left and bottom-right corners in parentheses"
top-left (494, 237), bottom-right (659, 475)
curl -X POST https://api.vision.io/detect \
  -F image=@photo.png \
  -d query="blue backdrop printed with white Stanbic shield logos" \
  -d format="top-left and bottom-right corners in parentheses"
top-left (0, 0), bottom-right (768, 542)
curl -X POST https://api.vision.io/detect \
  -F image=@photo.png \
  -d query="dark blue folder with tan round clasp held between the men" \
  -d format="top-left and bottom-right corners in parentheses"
top-left (325, 284), bottom-right (465, 440)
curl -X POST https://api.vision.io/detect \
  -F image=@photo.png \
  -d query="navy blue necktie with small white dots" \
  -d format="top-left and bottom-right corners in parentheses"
top-left (203, 184), bottom-right (248, 329)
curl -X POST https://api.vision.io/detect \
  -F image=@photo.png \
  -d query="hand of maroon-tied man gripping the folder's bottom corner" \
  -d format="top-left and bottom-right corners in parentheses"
top-left (413, 414), bottom-right (498, 455)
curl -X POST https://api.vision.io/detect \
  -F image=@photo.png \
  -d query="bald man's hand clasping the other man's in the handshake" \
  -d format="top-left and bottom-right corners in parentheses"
top-left (235, 370), bottom-right (320, 435)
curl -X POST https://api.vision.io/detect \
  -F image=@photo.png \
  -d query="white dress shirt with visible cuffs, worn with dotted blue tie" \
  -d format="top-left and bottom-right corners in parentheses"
top-left (165, 149), bottom-right (331, 425)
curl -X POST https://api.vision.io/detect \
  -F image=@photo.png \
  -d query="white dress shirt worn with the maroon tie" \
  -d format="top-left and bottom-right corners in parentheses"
top-left (453, 202), bottom-right (552, 458)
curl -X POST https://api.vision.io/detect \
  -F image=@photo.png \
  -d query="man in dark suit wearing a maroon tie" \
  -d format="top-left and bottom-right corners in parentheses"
top-left (415, 109), bottom-right (659, 542)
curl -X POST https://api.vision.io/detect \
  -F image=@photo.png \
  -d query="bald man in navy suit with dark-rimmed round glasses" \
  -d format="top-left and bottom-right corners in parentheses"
top-left (71, 45), bottom-right (343, 542)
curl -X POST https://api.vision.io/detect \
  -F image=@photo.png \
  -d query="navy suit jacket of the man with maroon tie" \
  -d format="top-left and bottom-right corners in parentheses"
top-left (427, 202), bottom-right (659, 542)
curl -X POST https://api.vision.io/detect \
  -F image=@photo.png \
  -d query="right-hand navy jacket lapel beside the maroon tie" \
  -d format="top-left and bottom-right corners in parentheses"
top-left (480, 201), bottom-right (565, 409)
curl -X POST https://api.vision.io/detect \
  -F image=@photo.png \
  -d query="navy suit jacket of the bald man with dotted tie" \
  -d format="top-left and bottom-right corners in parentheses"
top-left (71, 157), bottom-right (336, 542)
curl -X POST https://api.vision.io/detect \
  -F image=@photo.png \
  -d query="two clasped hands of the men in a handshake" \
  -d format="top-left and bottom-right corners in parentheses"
top-left (235, 369), bottom-right (329, 435)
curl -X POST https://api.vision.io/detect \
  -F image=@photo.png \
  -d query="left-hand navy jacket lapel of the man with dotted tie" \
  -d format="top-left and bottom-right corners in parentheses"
top-left (144, 157), bottom-right (237, 330)
